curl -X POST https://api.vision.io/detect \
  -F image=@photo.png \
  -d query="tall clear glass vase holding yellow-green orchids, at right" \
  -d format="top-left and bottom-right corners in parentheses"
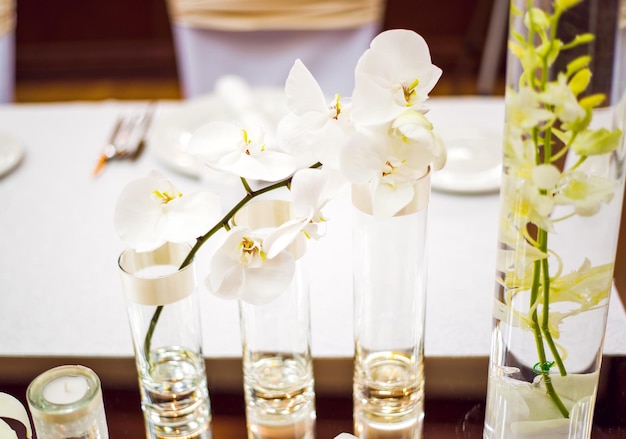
top-left (484, 0), bottom-right (626, 439)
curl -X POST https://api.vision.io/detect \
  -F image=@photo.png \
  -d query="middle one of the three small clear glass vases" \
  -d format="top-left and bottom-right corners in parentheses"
top-left (235, 200), bottom-right (316, 439)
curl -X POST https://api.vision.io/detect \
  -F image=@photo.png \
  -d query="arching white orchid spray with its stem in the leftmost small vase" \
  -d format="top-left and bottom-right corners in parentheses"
top-left (115, 30), bottom-right (445, 436)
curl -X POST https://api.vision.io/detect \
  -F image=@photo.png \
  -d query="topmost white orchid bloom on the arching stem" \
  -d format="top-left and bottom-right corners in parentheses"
top-left (352, 29), bottom-right (442, 125)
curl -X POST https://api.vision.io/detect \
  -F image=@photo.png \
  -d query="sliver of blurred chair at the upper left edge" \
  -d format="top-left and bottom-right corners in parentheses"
top-left (0, 0), bottom-right (15, 103)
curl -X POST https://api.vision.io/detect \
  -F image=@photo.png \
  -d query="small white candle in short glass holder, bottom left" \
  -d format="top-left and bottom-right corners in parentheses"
top-left (26, 366), bottom-right (109, 439)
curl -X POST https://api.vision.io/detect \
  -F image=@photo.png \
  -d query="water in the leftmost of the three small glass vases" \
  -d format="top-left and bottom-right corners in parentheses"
top-left (140, 347), bottom-right (212, 439)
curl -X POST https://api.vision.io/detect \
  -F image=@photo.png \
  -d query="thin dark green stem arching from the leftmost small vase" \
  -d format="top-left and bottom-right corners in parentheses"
top-left (143, 163), bottom-right (322, 369)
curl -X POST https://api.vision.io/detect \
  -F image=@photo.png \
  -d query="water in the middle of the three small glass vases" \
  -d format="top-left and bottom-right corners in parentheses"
top-left (244, 355), bottom-right (316, 439)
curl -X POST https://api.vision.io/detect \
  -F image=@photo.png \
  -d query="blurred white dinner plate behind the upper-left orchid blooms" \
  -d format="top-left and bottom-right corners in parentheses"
top-left (148, 88), bottom-right (287, 177)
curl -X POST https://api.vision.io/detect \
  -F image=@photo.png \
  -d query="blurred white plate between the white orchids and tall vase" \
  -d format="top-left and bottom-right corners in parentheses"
top-left (431, 127), bottom-right (502, 194)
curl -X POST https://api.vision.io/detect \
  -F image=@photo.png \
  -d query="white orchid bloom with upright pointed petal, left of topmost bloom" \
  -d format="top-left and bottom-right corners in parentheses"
top-left (277, 59), bottom-right (353, 169)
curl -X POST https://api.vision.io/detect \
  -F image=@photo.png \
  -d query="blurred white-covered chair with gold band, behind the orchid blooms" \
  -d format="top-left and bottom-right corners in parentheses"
top-left (167, 0), bottom-right (385, 98)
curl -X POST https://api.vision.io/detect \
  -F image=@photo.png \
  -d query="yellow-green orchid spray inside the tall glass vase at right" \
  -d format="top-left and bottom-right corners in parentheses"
top-left (496, 0), bottom-right (622, 418)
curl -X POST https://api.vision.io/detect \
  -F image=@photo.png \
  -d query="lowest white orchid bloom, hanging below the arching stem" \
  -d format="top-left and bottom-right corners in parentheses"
top-left (206, 226), bottom-right (295, 305)
